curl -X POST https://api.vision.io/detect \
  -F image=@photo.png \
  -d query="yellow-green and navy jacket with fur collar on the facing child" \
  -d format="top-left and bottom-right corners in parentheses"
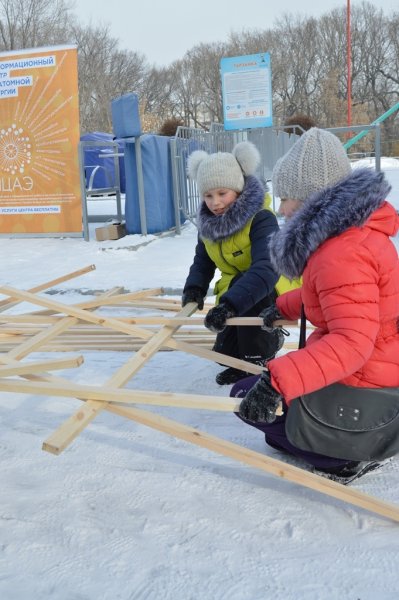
top-left (184, 176), bottom-right (298, 315)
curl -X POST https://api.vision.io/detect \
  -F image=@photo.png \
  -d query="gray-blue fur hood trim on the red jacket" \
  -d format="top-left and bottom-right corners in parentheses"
top-left (270, 169), bottom-right (391, 279)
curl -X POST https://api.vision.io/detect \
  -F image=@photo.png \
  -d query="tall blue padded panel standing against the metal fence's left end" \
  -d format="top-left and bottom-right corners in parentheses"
top-left (125, 134), bottom-right (183, 234)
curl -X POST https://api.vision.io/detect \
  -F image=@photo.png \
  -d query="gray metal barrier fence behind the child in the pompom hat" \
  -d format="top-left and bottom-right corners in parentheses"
top-left (171, 123), bottom-right (299, 233)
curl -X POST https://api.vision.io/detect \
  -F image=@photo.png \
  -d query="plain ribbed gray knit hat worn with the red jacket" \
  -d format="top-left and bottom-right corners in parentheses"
top-left (272, 127), bottom-right (352, 200)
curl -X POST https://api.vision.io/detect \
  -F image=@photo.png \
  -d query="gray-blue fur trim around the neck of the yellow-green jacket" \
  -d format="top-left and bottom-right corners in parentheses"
top-left (197, 175), bottom-right (265, 242)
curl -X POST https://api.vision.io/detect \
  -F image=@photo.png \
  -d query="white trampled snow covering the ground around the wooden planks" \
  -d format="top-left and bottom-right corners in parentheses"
top-left (0, 211), bottom-right (399, 600)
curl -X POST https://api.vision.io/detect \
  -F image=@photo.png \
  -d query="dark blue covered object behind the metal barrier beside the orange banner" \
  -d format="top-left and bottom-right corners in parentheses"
top-left (80, 131), bottom-right (126, 193)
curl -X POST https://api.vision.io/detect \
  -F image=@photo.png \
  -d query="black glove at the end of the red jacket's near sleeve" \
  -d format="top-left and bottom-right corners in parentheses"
top-left (238, 371), bottom-right (283, 423)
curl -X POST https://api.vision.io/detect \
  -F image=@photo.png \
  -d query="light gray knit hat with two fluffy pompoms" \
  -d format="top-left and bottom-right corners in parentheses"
top-left (187, 142), bottom-right (260, 196)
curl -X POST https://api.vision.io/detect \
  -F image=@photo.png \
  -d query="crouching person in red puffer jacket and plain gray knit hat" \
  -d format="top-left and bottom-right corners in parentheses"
top-left (232, 128), bottom-right (399, 482)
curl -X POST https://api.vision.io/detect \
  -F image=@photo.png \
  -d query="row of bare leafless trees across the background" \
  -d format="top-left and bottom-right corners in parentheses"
top-left (0, 0), bottom-right (399, 146)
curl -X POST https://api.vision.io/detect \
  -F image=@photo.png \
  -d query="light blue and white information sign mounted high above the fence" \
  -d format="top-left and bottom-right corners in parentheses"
top-left (220, 53), bottom-right (273, 130)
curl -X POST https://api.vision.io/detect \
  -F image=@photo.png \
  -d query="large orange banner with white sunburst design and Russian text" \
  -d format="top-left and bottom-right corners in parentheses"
top-left (0, 46), bottom-right (82, 236)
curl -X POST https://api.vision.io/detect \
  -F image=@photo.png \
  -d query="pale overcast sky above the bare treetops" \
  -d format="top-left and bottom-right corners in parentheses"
top-left (74, 0), bottom-right (397, 67)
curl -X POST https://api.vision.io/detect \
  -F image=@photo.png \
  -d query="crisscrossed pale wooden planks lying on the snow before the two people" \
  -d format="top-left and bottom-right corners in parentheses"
top-left (0, 265), bottom-right (399, 521)
